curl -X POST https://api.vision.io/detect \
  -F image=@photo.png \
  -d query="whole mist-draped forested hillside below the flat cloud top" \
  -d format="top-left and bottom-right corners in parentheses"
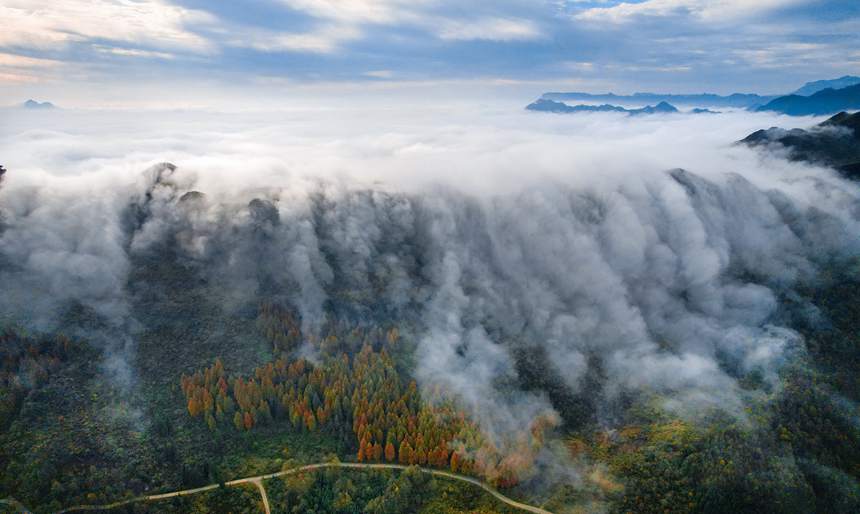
top-left (0, 157), bottom-right (860, 513)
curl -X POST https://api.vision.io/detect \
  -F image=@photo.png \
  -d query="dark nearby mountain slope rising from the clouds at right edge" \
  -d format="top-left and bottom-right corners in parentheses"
top-left (740, 112), bottom-right (860, 180)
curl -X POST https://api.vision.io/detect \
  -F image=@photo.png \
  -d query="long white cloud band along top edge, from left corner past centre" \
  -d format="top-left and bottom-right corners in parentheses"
top-left (0, 0), bottom-right (540, 59)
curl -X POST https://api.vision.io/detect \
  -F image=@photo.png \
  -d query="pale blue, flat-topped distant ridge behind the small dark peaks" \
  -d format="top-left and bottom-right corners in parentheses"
top-left (541, 93), bottom-right (776, 109)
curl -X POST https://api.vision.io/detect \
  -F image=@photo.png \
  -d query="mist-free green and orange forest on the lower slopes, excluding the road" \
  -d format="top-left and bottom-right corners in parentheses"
top-left (0, 246), bottom-right (860, 514)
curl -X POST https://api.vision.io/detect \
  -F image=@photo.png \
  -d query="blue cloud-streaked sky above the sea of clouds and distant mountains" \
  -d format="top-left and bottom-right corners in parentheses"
top-left (0, 0), bottom-right (860, 107)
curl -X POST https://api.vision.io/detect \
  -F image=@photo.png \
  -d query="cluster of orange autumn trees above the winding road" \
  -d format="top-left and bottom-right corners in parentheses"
top-left (180, 305), bottom-right (540, 480)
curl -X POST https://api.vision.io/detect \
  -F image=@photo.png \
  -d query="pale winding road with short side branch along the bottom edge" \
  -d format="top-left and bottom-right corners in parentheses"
top-left (57, 462), bottom-right (552, 514)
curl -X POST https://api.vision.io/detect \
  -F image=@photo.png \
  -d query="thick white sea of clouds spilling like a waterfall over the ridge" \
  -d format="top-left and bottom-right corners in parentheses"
top-left (0, 103), bottom-right (860, 480)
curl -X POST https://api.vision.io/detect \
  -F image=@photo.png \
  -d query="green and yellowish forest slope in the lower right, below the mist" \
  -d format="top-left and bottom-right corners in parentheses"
top-left (548, 266), bottom-right (860, 514)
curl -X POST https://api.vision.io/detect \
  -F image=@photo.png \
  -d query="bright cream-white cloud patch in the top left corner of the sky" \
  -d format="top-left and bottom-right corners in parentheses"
top-left (0, 0), bottom-right (214, 52)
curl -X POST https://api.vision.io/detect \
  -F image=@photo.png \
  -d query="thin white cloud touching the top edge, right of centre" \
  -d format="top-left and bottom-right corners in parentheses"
top-left (576, 0), bottom-right (800, 23)
